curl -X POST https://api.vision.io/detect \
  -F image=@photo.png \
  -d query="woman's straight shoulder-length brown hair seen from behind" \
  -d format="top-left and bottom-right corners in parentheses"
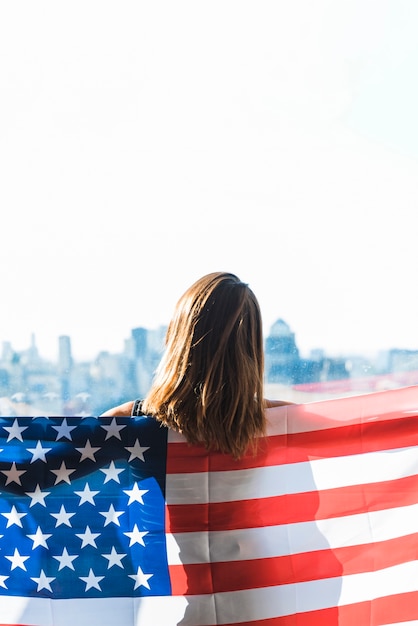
top-left (142, 272), bottom-right (265, 458)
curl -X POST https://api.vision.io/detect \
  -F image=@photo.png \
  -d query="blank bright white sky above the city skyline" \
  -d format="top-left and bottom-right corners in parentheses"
top-left (0, 0), bottom-right (418, 358)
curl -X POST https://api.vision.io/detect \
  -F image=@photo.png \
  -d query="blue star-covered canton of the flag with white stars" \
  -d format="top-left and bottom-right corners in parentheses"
top-left (0, 416), bottom-right (171, 602)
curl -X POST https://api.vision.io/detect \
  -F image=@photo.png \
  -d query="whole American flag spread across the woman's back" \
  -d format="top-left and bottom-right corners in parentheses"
top-left (0, 387), bottom-right (418, 626)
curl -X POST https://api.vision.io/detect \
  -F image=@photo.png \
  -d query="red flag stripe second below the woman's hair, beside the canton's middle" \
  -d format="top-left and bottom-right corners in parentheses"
top-left (166, 475), bottom-right (418, 533)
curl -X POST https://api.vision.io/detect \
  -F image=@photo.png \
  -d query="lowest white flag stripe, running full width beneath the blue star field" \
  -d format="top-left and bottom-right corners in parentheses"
top-left (0, 561), bottom-right (418, 626)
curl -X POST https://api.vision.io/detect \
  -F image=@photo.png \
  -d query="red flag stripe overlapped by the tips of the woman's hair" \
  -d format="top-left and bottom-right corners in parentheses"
top-left (167, 417), bottom-right (418, 474)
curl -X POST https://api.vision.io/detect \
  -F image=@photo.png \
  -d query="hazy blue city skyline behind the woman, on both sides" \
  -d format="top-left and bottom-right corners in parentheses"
top-left (0, 319), bottom-right (418, 416)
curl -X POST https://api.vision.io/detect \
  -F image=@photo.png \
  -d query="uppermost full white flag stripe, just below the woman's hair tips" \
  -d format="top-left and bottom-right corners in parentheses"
top-left (166, 447), bottom-right (418, 504)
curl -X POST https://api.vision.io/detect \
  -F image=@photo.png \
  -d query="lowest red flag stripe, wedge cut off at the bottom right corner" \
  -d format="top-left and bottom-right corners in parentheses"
top-left (200, 591), bottom-right (418, 626)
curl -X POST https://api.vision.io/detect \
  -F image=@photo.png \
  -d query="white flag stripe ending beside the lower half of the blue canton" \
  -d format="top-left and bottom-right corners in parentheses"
top-left (167, 504), bottom-right (418, 565)
